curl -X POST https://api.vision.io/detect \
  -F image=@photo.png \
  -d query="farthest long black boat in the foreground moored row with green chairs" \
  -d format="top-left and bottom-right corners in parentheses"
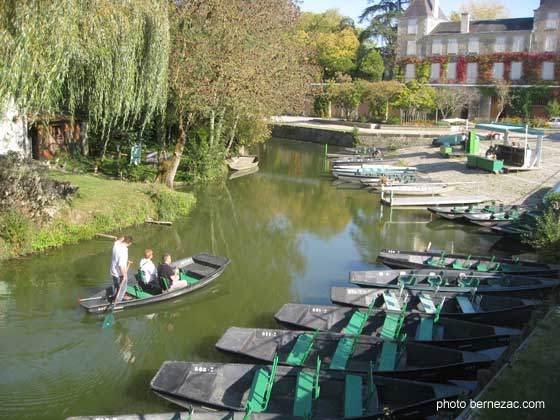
top-left (377, 249), bottom-right (560, 277)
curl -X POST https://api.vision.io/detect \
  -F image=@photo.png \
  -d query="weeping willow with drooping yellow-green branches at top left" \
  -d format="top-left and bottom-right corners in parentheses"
top-left (0, 0), bottom-right (169, 158)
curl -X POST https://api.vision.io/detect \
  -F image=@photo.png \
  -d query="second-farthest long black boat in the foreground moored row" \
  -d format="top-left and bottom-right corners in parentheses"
top-left (350, 269), bottom-right (560, 297)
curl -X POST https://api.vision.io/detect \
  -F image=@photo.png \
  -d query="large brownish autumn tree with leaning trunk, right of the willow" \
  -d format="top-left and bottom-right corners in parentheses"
top-left (157, 0), bottom-right (311, 186)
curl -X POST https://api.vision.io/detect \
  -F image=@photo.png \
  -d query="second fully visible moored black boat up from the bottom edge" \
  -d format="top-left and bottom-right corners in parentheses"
top-left (216, 327), bottom-right (494, 382)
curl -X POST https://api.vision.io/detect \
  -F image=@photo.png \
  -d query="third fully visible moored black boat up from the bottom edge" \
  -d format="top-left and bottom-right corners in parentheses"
top-left (274, 303), bottom-right (521, 351)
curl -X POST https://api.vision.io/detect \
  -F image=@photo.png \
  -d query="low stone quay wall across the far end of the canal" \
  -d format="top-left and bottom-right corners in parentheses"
top-left (271, 124), bottom-right (435, 149)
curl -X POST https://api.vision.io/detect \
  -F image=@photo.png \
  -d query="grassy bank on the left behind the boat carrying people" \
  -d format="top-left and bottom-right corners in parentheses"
top-left (0, 172), bottom-right (195, 259)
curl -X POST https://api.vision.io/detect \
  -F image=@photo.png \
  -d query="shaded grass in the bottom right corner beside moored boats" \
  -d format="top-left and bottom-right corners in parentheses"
top-left (473, 312), bottom-right (560, 420)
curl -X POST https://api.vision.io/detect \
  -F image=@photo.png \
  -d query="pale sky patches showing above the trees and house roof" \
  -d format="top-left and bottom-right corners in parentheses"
top-left (301, 0), bottom-right (540, 23)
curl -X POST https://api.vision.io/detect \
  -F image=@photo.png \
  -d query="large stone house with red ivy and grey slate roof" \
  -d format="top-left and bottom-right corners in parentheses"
top-left (397, 0), bottom-right (560, 118)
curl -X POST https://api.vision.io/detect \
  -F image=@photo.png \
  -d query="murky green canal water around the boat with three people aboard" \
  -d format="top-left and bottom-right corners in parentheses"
top-left (0, 139), bottom-right (512, 420)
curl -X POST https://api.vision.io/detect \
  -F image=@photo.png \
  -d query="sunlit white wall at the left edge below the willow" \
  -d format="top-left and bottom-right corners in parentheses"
top-left (0, 100), bottom-right (31, 159)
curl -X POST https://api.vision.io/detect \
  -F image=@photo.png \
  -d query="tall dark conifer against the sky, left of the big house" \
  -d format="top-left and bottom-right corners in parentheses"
top-left (360, 0), bottom-right (409, 75)
